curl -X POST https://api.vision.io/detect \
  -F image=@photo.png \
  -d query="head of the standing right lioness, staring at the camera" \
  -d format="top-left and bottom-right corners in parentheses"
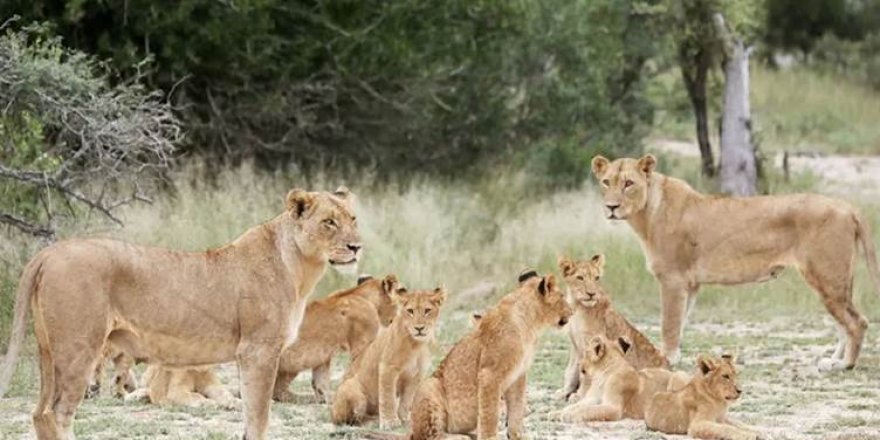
top-left (592, 154), bottom-right (657, 220)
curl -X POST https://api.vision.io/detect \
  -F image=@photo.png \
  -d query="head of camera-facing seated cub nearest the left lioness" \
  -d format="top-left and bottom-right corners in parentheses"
top-left (394, 287), bottom-right (446, 341)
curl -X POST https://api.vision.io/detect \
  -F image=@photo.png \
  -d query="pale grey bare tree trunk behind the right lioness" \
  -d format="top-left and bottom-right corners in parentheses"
top-left (714, 14), bottom-right (758, 196)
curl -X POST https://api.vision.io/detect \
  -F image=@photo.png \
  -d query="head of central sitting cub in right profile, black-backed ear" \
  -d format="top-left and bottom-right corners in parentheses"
top-left (517, 269), bottom-right (573, 327)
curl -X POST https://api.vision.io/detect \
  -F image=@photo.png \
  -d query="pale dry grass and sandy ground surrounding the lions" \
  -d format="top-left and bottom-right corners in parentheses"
top-left (0, 64), bottom-right (880, 439)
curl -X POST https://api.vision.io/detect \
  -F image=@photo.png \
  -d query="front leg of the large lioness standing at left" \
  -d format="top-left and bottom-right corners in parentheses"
top-left (237, 341), bottom-right (281, 440)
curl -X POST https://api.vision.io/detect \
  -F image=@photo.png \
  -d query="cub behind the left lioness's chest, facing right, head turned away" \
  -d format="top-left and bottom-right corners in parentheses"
top-left (273, 275), bottom-right (406, 403)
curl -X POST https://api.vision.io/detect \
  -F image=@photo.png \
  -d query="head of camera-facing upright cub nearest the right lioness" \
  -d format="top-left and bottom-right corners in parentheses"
top-left (559, 254), bottom-right (610, 308)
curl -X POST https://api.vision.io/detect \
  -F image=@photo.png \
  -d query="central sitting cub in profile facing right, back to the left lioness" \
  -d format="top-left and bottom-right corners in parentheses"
top-left (410, 271), bottom-right (572, 440)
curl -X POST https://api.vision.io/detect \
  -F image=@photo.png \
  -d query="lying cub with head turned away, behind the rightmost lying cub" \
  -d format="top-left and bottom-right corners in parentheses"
top-left (551, 336), bottom-right (674, 422)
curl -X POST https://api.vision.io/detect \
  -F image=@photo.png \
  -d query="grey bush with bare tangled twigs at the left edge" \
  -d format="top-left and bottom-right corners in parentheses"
top-left (0, 23), bottom-right (182, 240)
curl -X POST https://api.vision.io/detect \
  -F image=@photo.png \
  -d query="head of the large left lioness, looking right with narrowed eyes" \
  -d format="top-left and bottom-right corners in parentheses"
top-left (285, 187), bottom-right (363, 274)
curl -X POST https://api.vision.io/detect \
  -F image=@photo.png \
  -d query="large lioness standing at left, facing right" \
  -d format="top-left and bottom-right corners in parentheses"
top-left (0, 188), bottom-right (361, 440)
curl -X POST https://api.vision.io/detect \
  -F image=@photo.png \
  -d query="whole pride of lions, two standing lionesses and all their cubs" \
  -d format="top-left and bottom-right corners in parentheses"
top-left (0, 155), bottom-right (880, 440)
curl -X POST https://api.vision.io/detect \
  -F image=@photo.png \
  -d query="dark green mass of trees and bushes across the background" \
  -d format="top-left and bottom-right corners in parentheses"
top-left (0, 0), bottom-right (664, 180)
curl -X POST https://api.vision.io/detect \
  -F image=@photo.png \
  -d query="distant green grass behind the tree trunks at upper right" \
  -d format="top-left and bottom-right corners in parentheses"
top-left (652, 63), bottom-right (880, 155)
